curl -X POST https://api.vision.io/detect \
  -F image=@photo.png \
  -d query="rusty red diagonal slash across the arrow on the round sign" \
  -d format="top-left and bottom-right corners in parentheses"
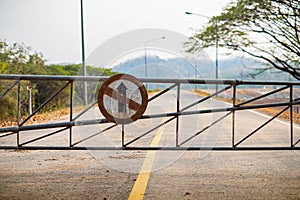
top-left (104, 87), bottom-right (141, 111)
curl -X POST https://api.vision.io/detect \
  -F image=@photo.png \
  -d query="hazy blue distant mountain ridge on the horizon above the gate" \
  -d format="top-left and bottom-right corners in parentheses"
top-left (113, 56), bottom-right (290, 81)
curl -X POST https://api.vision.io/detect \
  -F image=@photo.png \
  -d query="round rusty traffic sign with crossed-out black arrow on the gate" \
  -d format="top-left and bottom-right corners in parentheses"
top-left (98, 74), bottom-right (148, 124)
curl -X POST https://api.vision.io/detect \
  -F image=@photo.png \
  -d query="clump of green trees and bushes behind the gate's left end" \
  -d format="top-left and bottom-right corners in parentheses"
top-left (0, 40), bottom-right (116, 120)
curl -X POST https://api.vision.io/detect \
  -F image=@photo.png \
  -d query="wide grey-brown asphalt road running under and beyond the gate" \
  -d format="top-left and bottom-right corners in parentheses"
top-left (0, 91), bottom-right (300, 199)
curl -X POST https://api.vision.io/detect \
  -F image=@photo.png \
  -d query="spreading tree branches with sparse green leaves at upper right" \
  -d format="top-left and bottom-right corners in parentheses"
top-left (187, 0), bottom-right (300, 80)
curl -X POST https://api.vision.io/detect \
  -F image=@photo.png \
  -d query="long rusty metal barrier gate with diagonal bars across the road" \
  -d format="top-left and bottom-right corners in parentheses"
top-left (0, 75), bottom-right (300, 150)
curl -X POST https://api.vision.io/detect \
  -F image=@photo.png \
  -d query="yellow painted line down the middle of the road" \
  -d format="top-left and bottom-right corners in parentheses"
top-left (128, 122), bottom-right (164, 200)
